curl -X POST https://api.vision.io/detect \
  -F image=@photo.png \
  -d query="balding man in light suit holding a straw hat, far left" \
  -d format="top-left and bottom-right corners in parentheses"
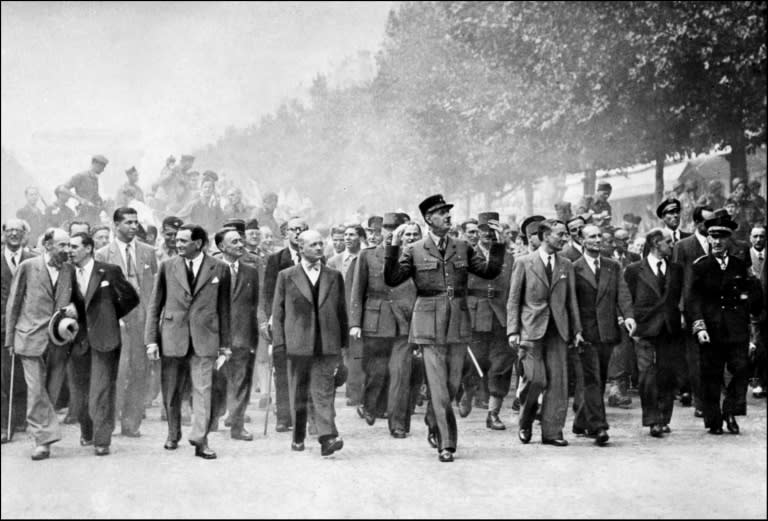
top-left (5, 228), bottom-right (77, 460)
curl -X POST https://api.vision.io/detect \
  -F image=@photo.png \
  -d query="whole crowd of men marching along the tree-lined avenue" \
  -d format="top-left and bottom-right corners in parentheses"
top-left (1, 155), bottom-right (768, 462)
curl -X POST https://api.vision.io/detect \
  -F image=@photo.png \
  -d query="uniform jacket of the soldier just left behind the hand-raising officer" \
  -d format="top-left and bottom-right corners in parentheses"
top-left (349, 246), bottom-right (416, 338)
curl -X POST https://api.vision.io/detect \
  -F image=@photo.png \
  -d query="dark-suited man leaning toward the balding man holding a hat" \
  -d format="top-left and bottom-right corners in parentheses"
top-left (69, 233), bottom-right (143, 456)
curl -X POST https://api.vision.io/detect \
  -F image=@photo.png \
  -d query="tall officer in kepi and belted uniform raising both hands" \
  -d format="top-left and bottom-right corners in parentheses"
top-left (384, 194), bottom-right (504, 462)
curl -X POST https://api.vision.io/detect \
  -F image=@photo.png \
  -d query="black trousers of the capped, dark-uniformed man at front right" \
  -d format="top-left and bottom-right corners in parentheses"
top-left (701, 342), bottom-right (749, 428)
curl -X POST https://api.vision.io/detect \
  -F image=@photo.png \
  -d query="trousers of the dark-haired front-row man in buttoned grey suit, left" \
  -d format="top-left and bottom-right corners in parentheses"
top-left (161, 346), bottom-right (216, 444)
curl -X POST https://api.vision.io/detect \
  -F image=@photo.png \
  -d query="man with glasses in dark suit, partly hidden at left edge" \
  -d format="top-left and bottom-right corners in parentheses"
top-left (0, 219), bottom-right (36, 443)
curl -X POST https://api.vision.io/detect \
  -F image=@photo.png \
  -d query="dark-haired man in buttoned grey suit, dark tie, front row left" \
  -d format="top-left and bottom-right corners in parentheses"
top-left (144, 224), bottom-right (232, 459)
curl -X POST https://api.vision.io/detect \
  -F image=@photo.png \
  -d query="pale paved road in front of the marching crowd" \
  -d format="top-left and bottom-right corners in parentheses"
top-left (0, 390), bottom-right (766, 519)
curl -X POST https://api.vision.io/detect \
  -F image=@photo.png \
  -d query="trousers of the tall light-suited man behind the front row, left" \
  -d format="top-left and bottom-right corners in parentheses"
top-left (117, 310), bottom-right (150, 434)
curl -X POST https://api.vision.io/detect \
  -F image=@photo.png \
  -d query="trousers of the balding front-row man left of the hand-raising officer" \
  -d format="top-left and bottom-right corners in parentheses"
top-left (288, 355), bottom-right (339, 443)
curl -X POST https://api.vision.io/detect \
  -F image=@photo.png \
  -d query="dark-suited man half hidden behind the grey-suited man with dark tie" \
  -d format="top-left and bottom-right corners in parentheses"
top-left (213, 228), bottom-right (260, 441)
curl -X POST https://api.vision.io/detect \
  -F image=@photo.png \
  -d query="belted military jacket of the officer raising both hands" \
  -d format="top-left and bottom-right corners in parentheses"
top-left (384, 234), bottom-right (504, 345)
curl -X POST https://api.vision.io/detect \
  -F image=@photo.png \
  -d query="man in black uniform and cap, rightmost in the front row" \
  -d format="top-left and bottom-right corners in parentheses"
top-left (686, 210), bottom-right (762, 434)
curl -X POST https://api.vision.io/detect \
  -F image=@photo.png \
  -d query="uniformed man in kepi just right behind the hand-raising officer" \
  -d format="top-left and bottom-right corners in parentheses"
top-left (459, 212), bottom-right (517, 430)
